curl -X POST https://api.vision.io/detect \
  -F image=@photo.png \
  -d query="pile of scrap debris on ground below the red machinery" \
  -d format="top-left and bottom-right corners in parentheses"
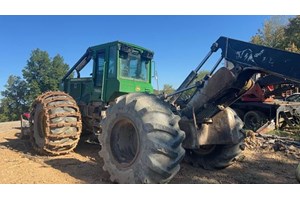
top-left (245, 130), bottom-right (300, 159)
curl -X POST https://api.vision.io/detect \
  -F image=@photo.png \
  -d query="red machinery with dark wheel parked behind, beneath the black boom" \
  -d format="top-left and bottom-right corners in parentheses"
top-left (231, 74), bottom-right (300, 131)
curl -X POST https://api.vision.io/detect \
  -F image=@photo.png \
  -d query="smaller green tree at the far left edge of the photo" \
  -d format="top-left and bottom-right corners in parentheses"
top-left (0, 75), bottom-right (29, 121)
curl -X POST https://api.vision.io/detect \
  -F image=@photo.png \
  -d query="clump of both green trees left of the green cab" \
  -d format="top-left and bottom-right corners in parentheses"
top-left (0, 49), bottom-right (69, 122)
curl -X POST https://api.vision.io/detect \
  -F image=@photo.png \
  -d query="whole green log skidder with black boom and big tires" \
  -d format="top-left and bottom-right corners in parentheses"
top-left (30, 37), bottom-right (300, 183)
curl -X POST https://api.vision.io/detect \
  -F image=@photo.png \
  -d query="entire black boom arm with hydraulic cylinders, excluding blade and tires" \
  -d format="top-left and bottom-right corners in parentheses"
top-left (175, 37), bottom-right (300, 123)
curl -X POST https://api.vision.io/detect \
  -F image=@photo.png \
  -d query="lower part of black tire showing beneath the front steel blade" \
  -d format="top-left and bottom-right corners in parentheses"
top-left (185, 141), bottom-right (244, 170)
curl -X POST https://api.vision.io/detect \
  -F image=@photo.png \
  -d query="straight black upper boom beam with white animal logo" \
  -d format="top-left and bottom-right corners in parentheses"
top-left (216, 37), bottom-right (300, 82)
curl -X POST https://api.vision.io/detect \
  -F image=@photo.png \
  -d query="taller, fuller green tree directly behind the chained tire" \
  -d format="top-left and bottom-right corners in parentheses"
top-left (22, 49), bottom-right (69, 103)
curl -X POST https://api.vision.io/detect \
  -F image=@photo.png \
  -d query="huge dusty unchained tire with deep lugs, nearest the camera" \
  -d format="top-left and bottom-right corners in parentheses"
top-left (99, 93), bottom-right (185, 183)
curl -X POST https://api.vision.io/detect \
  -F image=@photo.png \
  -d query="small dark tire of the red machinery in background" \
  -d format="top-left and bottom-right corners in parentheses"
top-left (244, 111), bottom-right (268, 131)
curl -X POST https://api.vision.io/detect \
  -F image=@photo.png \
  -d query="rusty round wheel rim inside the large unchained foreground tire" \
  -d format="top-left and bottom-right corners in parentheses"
top-left (110, 118), bottom-right (139, 168)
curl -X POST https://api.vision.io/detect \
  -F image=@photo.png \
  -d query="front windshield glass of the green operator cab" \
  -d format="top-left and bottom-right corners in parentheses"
top-left (120, 51), bottom-right (149, 82)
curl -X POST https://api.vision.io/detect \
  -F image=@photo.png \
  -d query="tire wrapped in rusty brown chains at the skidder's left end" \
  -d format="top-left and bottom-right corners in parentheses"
top-left (30, 91), bottom-right (82, 156)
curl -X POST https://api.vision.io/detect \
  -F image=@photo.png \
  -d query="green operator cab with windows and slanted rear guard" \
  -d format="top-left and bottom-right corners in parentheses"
top-left (60, 41), bottom-right (153, 105)
